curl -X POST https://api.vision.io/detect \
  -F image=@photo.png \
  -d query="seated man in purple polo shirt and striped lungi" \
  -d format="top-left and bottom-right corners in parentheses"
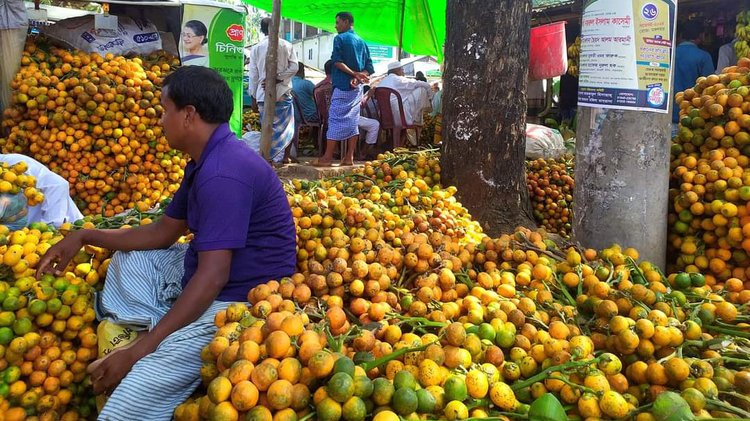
top-left (38, 66), bottom-right (296, 420)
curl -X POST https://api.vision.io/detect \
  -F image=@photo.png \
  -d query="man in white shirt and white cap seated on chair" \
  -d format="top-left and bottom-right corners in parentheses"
top-left (378, 61), bottom-right (432, 125)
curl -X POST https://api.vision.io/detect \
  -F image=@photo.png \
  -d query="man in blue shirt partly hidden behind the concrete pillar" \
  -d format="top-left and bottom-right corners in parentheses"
top-left (672, 21), bottom-right (714, 129)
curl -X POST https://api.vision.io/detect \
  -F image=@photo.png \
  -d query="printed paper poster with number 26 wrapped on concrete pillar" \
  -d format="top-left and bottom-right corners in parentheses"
top-left (578, 0), bottom-right (677, 114)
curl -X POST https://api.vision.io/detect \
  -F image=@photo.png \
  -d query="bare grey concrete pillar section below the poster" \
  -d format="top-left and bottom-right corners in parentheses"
top-left (573, 107), bottom-right (671, 268)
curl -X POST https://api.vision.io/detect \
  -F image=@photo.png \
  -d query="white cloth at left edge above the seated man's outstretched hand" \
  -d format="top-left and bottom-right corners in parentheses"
top-left (0, 153), bottom-right (83, 227)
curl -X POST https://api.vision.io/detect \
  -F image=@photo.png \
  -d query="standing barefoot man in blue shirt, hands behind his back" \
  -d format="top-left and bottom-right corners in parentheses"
top-left (315, 12), bottom-right (375, 167)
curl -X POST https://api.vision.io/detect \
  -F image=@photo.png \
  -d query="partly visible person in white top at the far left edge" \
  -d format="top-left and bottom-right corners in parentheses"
top-left (0, 0), bottom-right (29, 116)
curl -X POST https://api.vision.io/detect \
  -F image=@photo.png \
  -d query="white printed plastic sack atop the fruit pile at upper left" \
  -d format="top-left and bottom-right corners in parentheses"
top-left (42, 15), bottom-right (162, 55)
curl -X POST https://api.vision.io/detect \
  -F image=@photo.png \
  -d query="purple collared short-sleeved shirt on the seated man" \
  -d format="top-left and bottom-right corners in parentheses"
top-left (166, 124), bottom-right (297, 301)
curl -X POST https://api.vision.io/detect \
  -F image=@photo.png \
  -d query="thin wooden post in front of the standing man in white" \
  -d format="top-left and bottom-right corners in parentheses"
top-left (260, 0), bottom-right (281, 160)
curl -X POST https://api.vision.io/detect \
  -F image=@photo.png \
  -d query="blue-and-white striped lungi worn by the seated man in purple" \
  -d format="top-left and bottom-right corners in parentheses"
top-left (96, 244), bottom-right (231, 421)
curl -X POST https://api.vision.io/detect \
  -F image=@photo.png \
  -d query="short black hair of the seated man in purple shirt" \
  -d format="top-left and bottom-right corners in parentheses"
top-left (162, 66), bottom-right (234, 124)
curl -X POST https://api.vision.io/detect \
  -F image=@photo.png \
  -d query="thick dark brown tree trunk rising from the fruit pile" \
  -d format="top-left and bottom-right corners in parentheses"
top-left (441, 0), bottom-right (535, 235)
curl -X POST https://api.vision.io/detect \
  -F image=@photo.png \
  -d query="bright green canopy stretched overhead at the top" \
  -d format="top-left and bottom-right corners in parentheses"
top-left (242, 0), bottom-right (572, 61)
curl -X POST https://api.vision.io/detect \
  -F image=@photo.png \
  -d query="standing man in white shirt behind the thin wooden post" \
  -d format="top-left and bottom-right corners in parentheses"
top-left (247, 18), bottom-right (299, 163)
